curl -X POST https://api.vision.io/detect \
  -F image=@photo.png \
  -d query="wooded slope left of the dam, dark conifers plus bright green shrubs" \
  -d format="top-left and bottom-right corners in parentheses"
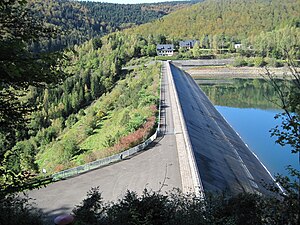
top-left (1, 30), bottom-right (164, 190)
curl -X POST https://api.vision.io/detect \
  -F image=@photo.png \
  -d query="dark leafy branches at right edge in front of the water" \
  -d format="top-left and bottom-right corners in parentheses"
top-left (266, 57), bottom-right (300, 224)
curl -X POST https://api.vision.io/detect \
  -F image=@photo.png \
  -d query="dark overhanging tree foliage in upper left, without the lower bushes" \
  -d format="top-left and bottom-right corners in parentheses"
top-left (0, 0), bottom-right (66, 137)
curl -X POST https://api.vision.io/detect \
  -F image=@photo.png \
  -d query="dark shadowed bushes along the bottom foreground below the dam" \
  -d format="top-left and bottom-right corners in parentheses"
top-left (73, 186), bottom-right (299, 225)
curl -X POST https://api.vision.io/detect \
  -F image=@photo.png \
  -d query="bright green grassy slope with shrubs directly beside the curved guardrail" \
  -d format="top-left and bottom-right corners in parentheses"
top-left (37, 59), bottom-right (159, 172)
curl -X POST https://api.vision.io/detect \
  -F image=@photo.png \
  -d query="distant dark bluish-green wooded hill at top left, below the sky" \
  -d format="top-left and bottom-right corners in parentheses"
top-left (28, 0), bottom-right (198, 51)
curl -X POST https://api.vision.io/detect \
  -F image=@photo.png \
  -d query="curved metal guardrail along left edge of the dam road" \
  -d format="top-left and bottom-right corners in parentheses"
top-left (52, 62), bottom-right (162, 181)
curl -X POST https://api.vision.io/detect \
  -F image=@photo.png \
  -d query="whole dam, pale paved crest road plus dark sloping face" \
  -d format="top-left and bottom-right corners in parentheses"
top-left (28, 62), bottom-right (274, 221)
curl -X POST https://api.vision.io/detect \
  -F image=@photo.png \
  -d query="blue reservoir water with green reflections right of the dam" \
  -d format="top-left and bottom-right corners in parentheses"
top-left (196, 79), bottom-right (299, 178)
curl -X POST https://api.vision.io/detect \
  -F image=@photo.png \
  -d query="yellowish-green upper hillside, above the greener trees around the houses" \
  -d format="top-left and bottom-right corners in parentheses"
top-left (129, 0), bottom-right (300, 40)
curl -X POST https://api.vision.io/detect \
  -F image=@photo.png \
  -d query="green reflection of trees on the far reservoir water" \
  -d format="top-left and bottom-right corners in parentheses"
top-left (200, 79), bottom-right (282, 109)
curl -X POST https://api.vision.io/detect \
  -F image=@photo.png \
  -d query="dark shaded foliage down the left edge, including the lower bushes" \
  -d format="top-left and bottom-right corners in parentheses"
top-left (0, 0), bottom-right (67, 197)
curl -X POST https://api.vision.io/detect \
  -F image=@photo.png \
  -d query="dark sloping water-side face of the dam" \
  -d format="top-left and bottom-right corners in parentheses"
top-left (170, 63), bottom-right (274, 194)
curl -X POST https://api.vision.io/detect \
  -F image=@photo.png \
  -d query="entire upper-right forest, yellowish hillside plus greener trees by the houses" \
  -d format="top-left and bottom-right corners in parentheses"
top-left (131, 0), bottom-right (300, 59)
